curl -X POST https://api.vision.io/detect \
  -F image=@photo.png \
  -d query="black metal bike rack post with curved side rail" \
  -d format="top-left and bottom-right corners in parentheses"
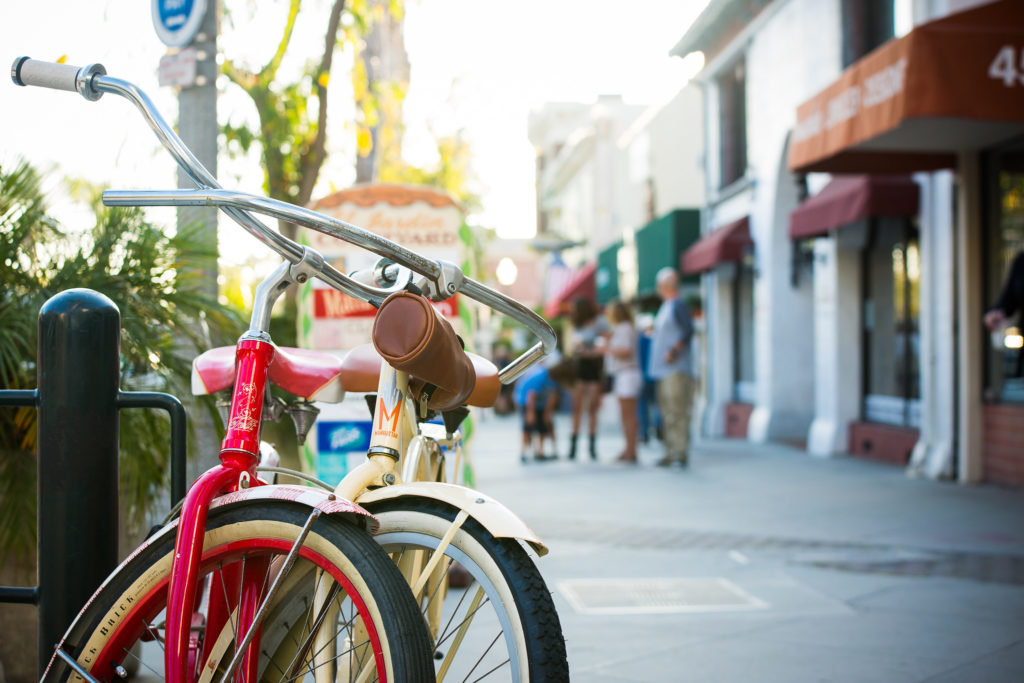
top-left (0, 289), bottom-right (186, 677)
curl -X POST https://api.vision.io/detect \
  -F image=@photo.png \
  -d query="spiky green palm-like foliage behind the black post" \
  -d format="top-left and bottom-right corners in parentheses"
top-left (0, 162), bottom-right (244, 557)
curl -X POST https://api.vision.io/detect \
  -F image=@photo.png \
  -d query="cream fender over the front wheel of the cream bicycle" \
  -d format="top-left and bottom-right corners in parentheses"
top-left (357, 481), bottom-right (548, 557)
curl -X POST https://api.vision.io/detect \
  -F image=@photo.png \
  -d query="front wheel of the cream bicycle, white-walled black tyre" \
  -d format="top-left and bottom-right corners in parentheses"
top-left (367, 498), bottom-right (568, 681)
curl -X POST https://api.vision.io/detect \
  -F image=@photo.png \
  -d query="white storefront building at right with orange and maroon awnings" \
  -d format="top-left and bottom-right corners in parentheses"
top-left (675, 0), bottom-right (1024, 486)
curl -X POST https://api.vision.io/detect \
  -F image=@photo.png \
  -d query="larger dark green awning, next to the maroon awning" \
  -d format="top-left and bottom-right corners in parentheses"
top-left (636, 209), bottom-right (700, 297)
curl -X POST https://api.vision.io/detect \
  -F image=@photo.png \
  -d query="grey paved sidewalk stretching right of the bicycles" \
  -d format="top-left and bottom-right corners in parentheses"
top-left (473, 401), bottom-right (1024, 682)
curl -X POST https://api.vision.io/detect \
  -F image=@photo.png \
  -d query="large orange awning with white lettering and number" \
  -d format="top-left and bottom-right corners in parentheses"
top-left (790, 0), bottom-right (1024, 173)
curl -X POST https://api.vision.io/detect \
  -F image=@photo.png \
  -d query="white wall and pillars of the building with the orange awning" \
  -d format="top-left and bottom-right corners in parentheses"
top-left (699, 0), bottom-right (974, 480)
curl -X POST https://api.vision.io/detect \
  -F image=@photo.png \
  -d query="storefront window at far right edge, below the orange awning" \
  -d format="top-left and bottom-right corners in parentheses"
top-left (985, 144), bottom-right (1024, 402)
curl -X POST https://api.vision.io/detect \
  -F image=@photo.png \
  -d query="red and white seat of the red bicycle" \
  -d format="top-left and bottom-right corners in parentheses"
top-left (191, 346), bottom-right (345, 403)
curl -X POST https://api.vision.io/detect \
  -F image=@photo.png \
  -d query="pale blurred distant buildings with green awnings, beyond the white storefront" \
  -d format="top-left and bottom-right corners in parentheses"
top-left (529, 86), bottom-right (705, 314)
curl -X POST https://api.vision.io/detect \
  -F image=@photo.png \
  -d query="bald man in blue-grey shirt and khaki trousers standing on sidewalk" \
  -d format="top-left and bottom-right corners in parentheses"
top-left (647, 267), bottom-right (696, 467)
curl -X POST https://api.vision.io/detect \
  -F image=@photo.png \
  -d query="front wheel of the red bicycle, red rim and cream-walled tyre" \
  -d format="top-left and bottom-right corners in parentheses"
top-left (44, 501), bottom-right (434, 683)
